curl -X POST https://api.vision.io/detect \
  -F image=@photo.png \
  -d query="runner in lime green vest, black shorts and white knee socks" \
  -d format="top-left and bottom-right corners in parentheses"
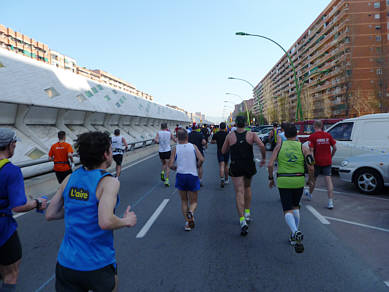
top-left (268, 125), bottom-right (314, 253)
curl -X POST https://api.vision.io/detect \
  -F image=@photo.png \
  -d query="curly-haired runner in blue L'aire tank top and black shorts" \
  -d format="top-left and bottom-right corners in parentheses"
top-left (46, 132), bottom-right (136, 292)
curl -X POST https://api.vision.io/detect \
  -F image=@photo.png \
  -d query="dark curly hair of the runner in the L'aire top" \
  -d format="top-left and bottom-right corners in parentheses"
top-left (75, 132), bottom-right (111, 169)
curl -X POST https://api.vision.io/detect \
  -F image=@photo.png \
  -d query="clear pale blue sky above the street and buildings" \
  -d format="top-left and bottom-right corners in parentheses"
top-left (0, 0), bottom-right (331, 121)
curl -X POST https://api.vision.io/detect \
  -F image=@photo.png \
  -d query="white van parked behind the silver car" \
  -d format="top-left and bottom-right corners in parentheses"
top-left (326, 113), bottom-right (389, 168)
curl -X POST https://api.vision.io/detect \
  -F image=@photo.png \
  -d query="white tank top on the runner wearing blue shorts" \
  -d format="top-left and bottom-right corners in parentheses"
top-left (175, 143), bottom-right (198, 176)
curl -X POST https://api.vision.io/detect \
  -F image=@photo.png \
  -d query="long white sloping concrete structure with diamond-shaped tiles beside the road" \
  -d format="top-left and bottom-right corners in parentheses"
top-left (0, 48), bottom-right (190, 162)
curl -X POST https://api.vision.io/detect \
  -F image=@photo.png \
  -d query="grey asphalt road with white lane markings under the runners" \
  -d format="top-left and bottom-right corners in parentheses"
top-left (13, 145), bottom-right (389, 292)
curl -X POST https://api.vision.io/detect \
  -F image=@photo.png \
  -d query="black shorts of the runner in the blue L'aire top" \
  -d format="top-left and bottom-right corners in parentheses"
top-left (55, 263), bottom-right (117, 292)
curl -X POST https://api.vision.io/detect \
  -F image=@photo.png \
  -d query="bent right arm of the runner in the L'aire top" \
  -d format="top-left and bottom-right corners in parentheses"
top-left (96, 177), bottom-right (136, 230)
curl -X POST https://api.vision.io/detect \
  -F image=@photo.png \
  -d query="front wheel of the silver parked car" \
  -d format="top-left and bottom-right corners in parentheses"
top-left (354, 168), bottom-right (383, 194)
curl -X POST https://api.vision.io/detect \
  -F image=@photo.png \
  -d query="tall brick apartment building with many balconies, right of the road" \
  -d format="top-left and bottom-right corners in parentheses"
top-left (253, 0), bottom-right (389, 122)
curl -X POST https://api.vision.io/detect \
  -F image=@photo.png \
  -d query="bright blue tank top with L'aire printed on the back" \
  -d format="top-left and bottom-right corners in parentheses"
top-left (58, 167), bottom-right (119, 271)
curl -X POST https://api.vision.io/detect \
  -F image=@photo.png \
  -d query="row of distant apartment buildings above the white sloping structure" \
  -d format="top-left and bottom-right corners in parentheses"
top-left (0, 24), bottom-right (153, 101)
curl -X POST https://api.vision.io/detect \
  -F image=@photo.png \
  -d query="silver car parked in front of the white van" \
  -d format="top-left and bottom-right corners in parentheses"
top-left (339, 154), bottom-right (389, 194)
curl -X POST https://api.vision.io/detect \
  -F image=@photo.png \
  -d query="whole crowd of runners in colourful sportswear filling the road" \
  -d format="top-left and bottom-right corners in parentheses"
top-left (0, 116), bottom-right (336, 292)
